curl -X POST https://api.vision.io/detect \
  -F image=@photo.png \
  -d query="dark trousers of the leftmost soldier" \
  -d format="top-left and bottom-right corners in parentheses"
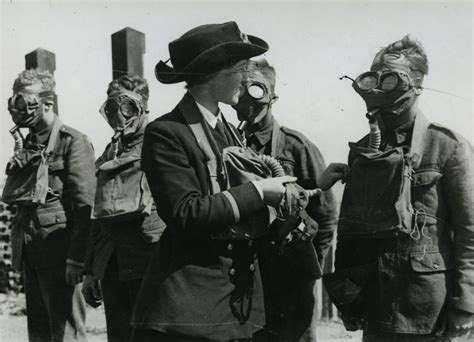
top-left (23, 261), bottom-right (87, 342)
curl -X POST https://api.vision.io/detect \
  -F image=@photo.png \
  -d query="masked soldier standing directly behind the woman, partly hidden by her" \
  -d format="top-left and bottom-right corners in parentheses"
top-left (233, 59), bottom-right (345, 342)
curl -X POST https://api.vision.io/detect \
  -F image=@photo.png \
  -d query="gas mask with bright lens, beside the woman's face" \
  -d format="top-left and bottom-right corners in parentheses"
top-left (232, 70), bottom-right (278, 128)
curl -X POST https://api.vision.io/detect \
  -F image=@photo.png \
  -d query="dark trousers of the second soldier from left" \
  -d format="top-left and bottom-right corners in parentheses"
top-left (101, 253), bottom-right (142, 342)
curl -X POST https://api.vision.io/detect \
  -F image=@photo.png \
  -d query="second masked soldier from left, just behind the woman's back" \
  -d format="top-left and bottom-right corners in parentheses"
top-left (82, 75), bottom-right (165, 341)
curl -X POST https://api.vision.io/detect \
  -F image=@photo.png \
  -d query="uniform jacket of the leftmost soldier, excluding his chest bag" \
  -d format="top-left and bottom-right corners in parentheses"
top-left (12, 119), bottom-right (95, 268)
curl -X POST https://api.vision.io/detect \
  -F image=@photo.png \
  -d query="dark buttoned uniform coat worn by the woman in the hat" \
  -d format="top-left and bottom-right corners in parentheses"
top-left (132, 94), bottom-right (265, 340)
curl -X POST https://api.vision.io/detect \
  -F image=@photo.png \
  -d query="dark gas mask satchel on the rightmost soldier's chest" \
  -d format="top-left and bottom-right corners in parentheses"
top-left (338, 143), bottom-right (414, 237)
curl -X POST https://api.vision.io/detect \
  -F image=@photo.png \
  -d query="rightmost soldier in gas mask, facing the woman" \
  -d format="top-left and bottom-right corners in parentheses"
top-left (336, 36), bottom-right (474, 342)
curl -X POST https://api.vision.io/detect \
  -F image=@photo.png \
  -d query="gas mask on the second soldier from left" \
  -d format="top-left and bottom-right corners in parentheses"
top-left (99, 90), bottom-right (146, 140)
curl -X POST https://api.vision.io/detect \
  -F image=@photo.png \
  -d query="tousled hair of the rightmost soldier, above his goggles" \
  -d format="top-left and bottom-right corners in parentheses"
top-left (372, 35), bottom-right (429, 83)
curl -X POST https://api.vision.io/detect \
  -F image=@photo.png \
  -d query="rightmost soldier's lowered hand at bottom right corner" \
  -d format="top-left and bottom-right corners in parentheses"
top-left (435, 309), bottom-right (474, 337)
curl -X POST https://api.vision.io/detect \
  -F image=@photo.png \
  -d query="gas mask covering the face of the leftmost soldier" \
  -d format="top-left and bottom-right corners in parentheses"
top-left (8, 91), bottom-right (54, 128)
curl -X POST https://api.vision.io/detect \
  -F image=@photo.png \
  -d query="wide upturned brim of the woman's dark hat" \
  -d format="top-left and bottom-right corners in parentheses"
top-left (155, 35), bottom-right (268, 84)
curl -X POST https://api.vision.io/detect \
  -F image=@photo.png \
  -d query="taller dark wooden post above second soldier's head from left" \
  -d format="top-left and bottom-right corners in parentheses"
top-left (111, 27), bottom-right (145, 79)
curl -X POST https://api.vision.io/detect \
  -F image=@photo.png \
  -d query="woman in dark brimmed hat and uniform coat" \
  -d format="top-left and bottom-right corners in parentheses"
top-left (132, 22), bottom-right (295, 341)
